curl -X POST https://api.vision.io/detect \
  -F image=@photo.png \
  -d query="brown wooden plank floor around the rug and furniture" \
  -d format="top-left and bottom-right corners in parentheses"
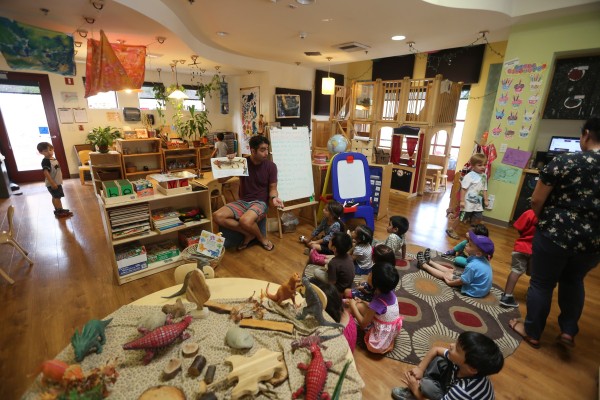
top-left (0, 179), bottom-right (600, 399)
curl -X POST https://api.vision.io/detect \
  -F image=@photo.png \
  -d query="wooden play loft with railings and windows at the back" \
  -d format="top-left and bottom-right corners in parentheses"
top-left (313, 75), bottom-right (463, 196)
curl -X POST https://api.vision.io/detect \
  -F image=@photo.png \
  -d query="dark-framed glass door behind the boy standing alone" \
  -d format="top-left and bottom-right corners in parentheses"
top-left (0, 72), bottom-right (69, 183)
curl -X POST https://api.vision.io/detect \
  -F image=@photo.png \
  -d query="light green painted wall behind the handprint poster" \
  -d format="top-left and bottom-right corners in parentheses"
top-left (485, 12), bottom-right (600, 222)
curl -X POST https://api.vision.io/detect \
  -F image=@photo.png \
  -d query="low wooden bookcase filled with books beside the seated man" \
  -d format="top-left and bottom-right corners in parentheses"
top-left (98, 190), bottom-right (212, 285)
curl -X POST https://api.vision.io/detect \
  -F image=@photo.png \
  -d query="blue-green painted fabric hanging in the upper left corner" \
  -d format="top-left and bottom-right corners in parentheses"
top-left (0, 17), bottom-right (75, 75)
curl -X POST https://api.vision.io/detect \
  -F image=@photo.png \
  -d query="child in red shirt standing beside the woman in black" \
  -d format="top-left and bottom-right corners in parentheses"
top-left (500, 210), bottom-right (537, 307)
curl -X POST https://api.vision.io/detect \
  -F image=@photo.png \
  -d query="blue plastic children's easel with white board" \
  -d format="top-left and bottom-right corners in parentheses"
top-left (331, 152), bottom-right (375, 230)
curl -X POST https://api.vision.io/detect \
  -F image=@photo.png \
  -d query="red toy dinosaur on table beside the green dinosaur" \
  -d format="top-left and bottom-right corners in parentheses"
top-left (123, 315), bottom-right (192, 364)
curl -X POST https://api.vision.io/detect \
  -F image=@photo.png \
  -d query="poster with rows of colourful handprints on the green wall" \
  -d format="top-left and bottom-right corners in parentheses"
top-left (491, 59), bottom-right (547, 141)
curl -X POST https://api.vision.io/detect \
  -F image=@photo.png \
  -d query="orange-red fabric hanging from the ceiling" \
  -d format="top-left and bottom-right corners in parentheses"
top-left (85, 31), bottom-right (146, 97)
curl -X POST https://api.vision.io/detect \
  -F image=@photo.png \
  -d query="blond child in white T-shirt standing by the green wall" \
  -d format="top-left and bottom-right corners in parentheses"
top-left (446, 153), bottom-right (489, 239)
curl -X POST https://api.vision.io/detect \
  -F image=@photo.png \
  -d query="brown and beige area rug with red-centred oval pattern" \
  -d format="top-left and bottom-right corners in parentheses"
top-left (304, 250), bottom-right (521, 364)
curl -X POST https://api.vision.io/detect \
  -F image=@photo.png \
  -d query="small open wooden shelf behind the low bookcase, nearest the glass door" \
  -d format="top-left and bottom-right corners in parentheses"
top-left (117, 138), bottom-right (164, 180)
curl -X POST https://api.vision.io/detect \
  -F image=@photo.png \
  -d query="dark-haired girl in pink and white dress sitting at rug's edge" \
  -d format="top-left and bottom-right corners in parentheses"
top-left (346, 263), bottom-right (402, 354)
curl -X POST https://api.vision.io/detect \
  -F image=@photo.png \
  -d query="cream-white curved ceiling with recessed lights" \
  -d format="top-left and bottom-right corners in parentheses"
top-left (0, 0), bottom-right (600, 75)
